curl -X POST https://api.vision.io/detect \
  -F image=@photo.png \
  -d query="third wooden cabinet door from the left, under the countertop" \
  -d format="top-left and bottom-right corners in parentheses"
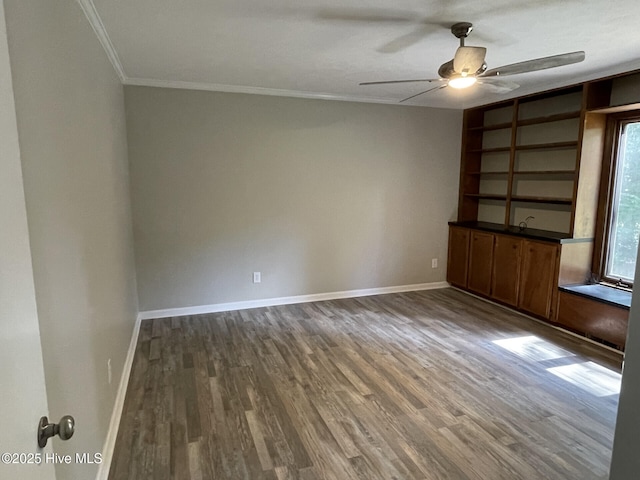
top-left (491, 235), bottom-right (523, 307)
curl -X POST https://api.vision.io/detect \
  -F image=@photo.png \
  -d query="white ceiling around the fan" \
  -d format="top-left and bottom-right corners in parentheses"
top-left (85, 0), bottom-right (640, 108)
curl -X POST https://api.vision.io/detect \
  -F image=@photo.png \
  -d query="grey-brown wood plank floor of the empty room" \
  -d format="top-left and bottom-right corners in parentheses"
top-left (109, 289), bottom-right (620, 480)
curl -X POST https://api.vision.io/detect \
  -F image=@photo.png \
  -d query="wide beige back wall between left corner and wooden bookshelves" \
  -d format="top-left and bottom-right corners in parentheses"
top-left (125, 87), bottom-right (462, 311)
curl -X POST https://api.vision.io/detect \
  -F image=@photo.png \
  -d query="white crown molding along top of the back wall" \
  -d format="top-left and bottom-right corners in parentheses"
top-left (122, 78), bottom-right (424, 108)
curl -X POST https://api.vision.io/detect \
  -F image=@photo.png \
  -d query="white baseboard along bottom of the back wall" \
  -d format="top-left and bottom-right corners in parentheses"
top-left (140, 282), bottom-right (449, 320)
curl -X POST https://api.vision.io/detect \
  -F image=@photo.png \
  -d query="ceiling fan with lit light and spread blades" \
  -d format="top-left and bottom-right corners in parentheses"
top-left (360, 22), bottom-right (584, 103)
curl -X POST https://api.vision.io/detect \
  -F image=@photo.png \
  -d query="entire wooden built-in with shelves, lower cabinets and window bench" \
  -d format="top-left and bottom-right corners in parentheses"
top-left (447, 68), bottom-right (640, 348)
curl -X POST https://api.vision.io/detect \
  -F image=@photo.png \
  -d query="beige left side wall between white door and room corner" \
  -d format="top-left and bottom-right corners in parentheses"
top-left (5, 0), bottom-right (137, 480)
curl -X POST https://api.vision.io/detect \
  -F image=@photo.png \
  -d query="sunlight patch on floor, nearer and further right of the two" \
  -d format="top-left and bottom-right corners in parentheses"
top-left (547, 362), bottom-right (622, 397)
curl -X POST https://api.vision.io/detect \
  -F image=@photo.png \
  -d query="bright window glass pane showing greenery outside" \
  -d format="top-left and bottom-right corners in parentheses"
top-left (602, 114), bottom-right (640, 286)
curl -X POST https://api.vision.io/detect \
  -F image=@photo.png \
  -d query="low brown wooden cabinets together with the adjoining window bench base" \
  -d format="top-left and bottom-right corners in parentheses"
top-left (447, 225), bottom-right (629, 348)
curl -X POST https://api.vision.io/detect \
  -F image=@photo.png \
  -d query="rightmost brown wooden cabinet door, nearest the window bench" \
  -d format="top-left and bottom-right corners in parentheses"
top-left (518, 240), bottom-right (558, 319)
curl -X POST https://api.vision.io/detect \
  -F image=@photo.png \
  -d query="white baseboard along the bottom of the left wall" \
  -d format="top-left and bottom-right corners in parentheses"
top-left (96, 314), bottom-right (142, 480)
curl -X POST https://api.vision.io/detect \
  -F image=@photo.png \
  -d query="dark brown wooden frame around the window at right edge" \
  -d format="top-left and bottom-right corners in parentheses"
top-left (592, 110), bottom-right (640, 290)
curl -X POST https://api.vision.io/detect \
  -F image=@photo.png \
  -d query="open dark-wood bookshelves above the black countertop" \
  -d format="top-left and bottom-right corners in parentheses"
top-left (458, 81), bottom-right (611, 237)
